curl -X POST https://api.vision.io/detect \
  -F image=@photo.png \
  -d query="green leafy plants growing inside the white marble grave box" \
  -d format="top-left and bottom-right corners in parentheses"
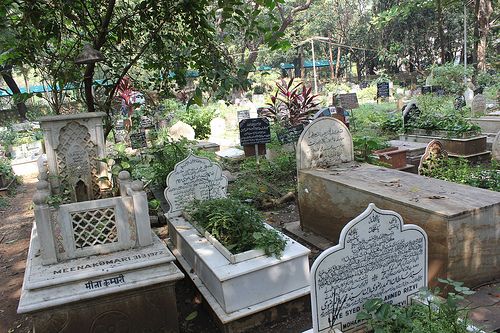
top-left (186, 198), bottom-right (286, 258)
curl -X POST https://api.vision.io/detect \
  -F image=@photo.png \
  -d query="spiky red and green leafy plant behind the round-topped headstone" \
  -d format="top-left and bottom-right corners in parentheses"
top-left (263, 79), bottom-right (319, 127)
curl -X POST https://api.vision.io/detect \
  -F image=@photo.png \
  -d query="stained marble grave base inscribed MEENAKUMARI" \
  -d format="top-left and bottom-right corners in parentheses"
top-left (18, 224), bottom-right (184, 333)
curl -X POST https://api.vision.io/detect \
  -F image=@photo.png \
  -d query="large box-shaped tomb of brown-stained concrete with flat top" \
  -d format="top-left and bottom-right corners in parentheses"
top-left (298, 163), bottom-right (500, 286)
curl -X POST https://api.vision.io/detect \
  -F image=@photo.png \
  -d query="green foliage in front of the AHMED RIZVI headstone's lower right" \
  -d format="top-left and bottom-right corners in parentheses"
top-left (356, 279), bottom-right (480, 333)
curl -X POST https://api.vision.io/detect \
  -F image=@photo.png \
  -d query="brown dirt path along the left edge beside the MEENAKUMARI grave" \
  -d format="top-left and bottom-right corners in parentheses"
top-left (0, 176), bottom-right (37, 333)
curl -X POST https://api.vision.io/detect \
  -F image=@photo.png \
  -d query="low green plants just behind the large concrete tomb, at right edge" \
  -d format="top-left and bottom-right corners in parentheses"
top-left (427, 158), bottom-right (500, 192)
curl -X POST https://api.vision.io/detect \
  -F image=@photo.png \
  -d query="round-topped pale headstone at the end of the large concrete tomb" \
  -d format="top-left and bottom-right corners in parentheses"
top-left (297, 117), bottom-right (354, 170)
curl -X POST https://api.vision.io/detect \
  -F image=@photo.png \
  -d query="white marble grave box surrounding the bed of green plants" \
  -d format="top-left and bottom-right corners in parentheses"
top-left (168, 217), bottom-right (309, 314)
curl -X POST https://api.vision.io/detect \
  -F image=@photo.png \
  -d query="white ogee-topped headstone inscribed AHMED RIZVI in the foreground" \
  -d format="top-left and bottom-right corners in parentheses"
top-left (311, 203), bottom-right (428, 332)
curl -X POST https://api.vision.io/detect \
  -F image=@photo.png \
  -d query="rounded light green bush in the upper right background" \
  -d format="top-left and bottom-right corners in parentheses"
top-left (430, 63), bottom-right (473, 95)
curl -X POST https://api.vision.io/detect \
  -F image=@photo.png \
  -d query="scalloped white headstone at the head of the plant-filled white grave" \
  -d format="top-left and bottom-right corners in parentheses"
top-left (164, 155), bottom-right (227, 217)
